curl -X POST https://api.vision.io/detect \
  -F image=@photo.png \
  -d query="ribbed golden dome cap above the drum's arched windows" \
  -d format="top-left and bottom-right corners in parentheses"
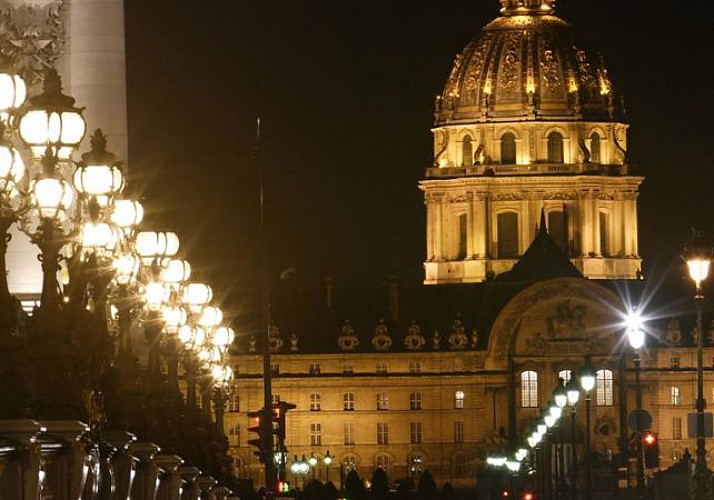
top-left (435, 0), bottom-right (618, 126)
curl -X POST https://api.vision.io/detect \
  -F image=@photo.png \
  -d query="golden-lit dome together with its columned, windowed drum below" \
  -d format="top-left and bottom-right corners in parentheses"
top-left (420, 0), bottom-right (642, 284)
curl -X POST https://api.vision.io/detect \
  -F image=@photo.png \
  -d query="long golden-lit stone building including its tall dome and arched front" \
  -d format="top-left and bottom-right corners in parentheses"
top-left (226, 0), bottom-right (714, 488)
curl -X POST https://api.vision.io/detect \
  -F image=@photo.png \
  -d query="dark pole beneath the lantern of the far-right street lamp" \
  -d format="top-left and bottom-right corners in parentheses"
top-left (693, 292), bottom-right (712, 500)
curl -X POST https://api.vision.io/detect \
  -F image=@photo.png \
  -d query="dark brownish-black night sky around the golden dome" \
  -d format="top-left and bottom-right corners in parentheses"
top-left (126, 0), bottom-right (714, 312)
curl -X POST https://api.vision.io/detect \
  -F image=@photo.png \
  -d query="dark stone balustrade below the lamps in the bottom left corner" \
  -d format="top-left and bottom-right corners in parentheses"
top-left (0, 420), bottom-right (237, 500)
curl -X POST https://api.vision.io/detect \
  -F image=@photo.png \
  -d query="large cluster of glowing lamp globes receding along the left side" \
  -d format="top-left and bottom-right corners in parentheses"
top-left (0, 64), bottom-right (234, 384)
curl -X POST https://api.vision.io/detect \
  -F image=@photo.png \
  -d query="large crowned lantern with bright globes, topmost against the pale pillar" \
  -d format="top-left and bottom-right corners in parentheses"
top-left (19, 69), bottom-right (87, 160)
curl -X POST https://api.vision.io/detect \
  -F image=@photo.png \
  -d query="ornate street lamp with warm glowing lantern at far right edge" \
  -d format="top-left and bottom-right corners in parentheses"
top-left (684, 232), bottom-right (712, 500)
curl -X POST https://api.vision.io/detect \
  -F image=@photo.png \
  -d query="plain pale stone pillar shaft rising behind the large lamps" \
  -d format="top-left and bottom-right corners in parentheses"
top-left (63, 0), bottom-right (129, 161)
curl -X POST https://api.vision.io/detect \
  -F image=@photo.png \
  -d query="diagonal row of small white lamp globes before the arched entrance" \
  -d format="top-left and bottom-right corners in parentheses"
top-left (486, 370), bottom-right (595, 473)
